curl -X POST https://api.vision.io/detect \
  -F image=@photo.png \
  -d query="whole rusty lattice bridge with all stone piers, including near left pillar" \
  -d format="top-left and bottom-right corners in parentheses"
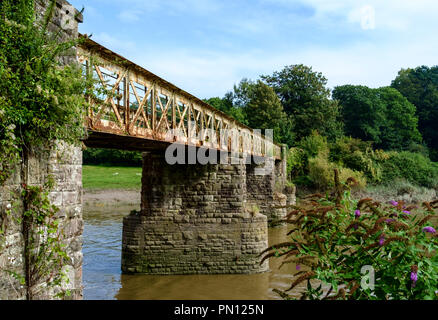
top-left (0, 0), bottom-right (294, 299)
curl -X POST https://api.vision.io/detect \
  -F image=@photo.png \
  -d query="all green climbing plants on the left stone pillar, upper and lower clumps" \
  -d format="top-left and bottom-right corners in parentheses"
top-left (0, 0), bottom-right (88, 299)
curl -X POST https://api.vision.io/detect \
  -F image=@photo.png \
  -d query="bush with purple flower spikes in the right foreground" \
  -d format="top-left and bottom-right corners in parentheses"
top-left (263, 182), bottom-right (438, 300)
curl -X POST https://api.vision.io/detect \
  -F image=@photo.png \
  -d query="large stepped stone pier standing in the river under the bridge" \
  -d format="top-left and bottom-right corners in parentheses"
top-left (122, 153), bottom-right (268, 274)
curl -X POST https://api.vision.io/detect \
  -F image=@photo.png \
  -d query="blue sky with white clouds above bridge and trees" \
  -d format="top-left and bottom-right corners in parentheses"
top-left (69, 0), bottom-right (438, 99)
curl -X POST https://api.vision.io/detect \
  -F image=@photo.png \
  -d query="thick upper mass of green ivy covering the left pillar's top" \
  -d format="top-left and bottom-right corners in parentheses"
top-left (0, 0), bottom-right (88, 183)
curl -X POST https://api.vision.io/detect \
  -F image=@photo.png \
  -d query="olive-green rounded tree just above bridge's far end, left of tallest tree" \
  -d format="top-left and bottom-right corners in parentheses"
top-left (243, 80), bottom-right (291, 143)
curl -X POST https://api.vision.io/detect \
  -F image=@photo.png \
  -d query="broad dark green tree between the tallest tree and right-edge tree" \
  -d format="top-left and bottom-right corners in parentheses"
top-left (333, 85), bottom-right (421, 149)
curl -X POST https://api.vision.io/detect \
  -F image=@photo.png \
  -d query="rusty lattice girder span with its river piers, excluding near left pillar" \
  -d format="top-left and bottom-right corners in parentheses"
top-left (77, 36), bottom-right (292, 274)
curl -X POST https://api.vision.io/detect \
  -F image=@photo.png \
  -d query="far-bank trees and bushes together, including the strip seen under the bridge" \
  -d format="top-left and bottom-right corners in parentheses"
top-left (84, 64), bottom-right (438, 190)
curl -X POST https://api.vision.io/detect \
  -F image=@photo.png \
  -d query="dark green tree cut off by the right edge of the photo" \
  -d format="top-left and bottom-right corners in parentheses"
top-left (391, 66), bottom-right (438, 159)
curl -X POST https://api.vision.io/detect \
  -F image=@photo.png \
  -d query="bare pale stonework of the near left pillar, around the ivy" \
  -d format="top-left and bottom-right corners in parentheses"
top-left (0, 0), bottom-right (83, 300)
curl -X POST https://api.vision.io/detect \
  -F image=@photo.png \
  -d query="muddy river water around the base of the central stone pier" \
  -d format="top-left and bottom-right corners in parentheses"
top-left (83, 205), bottom-right (302, 300)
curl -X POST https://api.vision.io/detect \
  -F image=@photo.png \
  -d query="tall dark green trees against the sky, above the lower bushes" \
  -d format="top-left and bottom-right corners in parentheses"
top-left (205, 64), bottom-right (438, 160)
